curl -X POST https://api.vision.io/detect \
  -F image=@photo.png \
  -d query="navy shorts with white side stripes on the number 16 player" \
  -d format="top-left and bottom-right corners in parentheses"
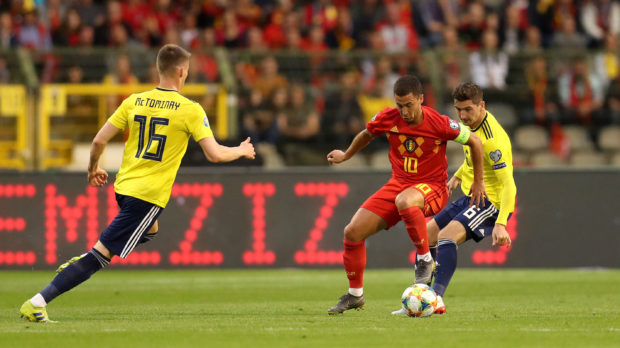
top-left (99, 193), bottom-right (164, 258)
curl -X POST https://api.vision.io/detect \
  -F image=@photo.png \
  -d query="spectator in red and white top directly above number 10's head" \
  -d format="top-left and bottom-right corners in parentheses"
top-left (377, 2), bottom-right (419, 52)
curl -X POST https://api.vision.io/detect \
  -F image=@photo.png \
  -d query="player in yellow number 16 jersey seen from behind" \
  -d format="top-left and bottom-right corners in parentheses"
top-left (20, 44), bottom-right (255, 322)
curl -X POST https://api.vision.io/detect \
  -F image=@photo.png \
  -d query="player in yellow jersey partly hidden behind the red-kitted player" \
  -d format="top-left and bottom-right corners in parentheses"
top-left (427, 82), bottom-right (517, 314)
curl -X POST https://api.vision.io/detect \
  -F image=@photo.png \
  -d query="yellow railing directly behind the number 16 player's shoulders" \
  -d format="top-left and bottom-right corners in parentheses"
top-left (38, 84), bottom-right (229, 169)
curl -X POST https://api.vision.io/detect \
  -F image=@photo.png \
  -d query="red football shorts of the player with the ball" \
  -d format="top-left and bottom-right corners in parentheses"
top-left (361, 178), bottom-right (449, 228)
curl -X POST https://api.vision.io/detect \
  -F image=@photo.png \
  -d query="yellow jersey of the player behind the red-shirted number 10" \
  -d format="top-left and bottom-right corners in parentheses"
top-left (454, 111), bottom-right (517, 225)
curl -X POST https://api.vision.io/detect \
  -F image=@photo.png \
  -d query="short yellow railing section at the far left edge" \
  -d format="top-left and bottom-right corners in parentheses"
top-left (0, 85), bottom-right (31, 170)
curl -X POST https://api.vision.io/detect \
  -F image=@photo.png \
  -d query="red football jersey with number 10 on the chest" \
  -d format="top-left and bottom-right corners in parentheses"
top-left (366, 106), bottom-right (461, 184)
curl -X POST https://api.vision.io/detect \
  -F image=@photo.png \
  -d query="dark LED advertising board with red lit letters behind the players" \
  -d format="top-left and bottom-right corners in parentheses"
top-left (0, 169), bottom-right (620, 269)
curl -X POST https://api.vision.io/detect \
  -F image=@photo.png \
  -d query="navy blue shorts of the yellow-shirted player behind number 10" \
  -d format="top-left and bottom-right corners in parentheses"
top-left (435, 196), bottom-right (512, 243)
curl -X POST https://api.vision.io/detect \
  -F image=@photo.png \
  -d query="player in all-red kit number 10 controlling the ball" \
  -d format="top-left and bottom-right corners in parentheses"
top-left (327, 75), bottom-right (486, 314)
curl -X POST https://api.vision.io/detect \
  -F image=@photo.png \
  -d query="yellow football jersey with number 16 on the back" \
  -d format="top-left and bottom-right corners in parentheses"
top-left (108, 88), bottom-right (213, 208)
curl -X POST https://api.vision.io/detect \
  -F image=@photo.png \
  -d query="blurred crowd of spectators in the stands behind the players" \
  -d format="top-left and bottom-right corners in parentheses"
top-left (0, 0), bottom-right (620, 165)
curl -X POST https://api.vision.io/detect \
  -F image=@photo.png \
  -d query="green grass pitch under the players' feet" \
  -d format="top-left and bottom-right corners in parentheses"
top-left (0, 270), bottom-right (620, 348)
